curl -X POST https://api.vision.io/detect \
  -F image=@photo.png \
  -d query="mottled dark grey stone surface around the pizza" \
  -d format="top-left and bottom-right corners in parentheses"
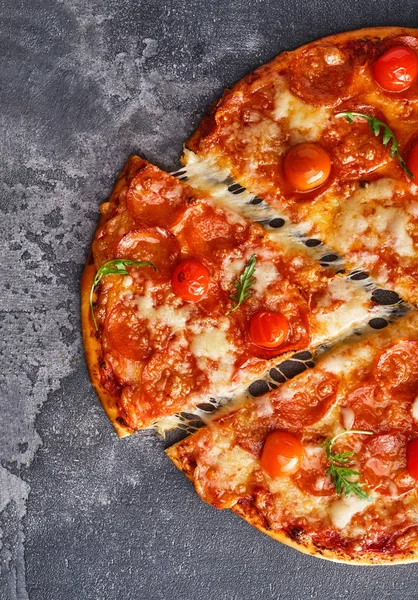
top-left (0, 0), bottom-right (418, 600)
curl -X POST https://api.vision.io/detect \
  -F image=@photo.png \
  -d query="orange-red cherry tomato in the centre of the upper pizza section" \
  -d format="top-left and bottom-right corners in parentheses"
top-left (283, 143), bottom-right (331, 192)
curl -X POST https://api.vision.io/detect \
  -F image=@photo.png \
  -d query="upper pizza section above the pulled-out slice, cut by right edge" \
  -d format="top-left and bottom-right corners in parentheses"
top-left (183, 27), bottom-right (418, 304)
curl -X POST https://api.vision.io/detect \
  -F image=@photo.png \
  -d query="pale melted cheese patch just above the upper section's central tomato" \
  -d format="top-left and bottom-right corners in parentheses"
top-left (274, 79), bottom-right (331, 144)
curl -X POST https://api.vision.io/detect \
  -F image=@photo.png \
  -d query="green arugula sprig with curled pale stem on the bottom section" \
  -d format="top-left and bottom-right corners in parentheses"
top-left (321, 429), bottom-right (373, 500)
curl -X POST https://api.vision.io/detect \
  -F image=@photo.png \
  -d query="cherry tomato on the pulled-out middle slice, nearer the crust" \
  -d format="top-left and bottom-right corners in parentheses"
top-left (171, 259), bottom-right (209, 302)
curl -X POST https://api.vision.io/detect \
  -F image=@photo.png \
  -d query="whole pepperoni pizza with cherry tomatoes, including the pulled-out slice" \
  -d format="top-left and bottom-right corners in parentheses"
top-left (81, 28), bottom-right (418, 564)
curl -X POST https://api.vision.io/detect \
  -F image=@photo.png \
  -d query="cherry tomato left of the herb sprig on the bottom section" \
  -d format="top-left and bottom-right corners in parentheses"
top-left (261, 431), bottom-right (305, 477)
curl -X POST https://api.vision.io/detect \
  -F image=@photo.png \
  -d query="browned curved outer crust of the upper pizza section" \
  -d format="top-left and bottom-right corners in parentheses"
top-left (185, 27), bottom-right (418, 154)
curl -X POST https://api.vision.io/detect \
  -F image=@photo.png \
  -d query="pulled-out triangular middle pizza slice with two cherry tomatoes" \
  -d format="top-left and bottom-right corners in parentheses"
top-left (81, 156), bottom-right (386, 435)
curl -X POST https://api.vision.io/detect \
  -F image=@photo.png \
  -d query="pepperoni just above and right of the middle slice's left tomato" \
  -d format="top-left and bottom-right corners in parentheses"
top-left (180, 205), bottom-right (249, 257)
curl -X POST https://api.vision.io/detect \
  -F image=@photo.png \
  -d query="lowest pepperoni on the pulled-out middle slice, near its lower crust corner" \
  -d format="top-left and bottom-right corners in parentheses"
top-left (142, 342), bottom-right (208, 414)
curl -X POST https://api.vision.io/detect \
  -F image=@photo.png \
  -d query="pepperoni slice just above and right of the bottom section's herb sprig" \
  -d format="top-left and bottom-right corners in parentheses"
top-left (345, 384), bottom-right (412, 433)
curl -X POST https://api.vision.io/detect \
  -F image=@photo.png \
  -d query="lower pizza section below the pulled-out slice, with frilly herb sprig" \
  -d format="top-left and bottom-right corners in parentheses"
top-left (166, 312), bottom-right (418, 564)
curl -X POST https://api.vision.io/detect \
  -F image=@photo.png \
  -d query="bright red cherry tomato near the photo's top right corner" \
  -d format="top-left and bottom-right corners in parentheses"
top-left (373, 46), bottom-right (418, 92)
